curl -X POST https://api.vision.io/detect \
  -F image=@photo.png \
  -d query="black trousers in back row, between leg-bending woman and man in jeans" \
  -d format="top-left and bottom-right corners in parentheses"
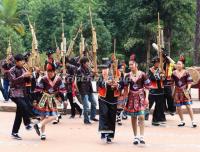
top-left (67, 93), bottom-right (82, 116)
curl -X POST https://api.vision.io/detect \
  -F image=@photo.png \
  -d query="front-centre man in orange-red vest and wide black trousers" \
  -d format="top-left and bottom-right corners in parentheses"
top-left (97, 57), bottom-right (120, 140)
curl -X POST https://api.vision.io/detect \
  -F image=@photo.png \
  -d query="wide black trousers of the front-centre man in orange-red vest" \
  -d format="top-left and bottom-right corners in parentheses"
top-left (99, 98), bottom-right (117, 138)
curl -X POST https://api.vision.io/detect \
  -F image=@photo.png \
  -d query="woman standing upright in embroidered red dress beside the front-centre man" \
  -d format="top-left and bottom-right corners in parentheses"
top-left (123, 57), bottom-right (150, 145)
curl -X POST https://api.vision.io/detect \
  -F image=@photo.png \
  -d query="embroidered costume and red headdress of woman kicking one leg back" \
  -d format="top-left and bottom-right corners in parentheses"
top-left (34, 64), bottom-right (66, 116)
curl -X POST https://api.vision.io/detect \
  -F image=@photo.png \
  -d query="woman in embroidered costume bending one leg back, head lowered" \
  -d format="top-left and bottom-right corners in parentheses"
top-left (34, 63), bottom-right (65, 140)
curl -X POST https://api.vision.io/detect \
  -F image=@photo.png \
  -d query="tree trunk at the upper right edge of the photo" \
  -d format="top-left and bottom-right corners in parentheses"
top-left (194, 0), bottom-right (200, 66)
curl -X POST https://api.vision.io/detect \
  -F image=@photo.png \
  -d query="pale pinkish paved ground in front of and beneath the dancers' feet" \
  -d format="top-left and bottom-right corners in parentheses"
top-left (0, 112), bottom-right (200, 152)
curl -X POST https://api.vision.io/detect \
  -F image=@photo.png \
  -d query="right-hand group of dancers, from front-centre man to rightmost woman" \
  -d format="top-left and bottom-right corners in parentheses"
top-left (97, 53), bottom-right (197, 145)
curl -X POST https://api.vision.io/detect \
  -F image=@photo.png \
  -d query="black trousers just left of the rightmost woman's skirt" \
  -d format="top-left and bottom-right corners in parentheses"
top-left (164, 86), bottom-right (176, 112)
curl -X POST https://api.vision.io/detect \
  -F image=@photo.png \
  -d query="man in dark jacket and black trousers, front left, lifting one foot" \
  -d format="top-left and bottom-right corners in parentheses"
top-left (8, 54), bottom-right (32, 140)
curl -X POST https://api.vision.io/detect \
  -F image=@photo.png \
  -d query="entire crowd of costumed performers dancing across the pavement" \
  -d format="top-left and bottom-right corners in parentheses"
top-left (0, 51), bottom-right (197, 145)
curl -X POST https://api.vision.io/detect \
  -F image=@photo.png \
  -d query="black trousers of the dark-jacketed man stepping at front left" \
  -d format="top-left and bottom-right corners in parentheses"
top-left (11, 97), bottom-right (31, 133)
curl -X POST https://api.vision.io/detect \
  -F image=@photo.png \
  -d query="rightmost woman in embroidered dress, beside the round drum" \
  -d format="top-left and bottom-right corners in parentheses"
top-left (172, 56), bottom-right (197, 128)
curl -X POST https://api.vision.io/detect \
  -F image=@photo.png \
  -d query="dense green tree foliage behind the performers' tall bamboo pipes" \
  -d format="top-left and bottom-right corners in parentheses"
top-left (0, 0), bottom-right (196, 67)
